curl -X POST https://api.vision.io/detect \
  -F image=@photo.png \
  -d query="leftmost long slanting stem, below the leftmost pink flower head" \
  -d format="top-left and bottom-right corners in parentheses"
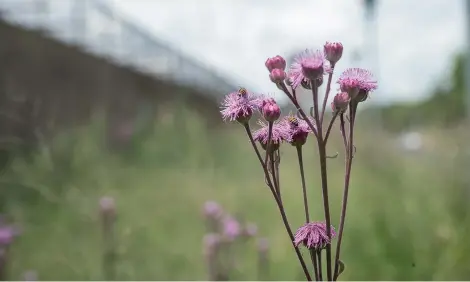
top-left (244, 123), bottom-right (312, 281)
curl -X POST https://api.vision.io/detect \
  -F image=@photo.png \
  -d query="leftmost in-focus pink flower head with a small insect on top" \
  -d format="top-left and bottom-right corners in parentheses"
top-left (220, 88), bottom-right (259, 124)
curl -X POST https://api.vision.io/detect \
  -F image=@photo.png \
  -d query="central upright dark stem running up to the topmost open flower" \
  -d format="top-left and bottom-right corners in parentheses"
top-left (311, 81), bottom-right (333, 281)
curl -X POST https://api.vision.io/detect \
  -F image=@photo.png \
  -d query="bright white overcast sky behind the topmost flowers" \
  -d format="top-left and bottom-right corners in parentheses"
top-left (107, 0), bottom-right (465, 105)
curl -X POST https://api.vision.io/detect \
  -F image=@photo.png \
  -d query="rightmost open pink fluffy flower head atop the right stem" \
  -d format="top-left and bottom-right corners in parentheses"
top-left (338, 68), bottom-right (377, 100)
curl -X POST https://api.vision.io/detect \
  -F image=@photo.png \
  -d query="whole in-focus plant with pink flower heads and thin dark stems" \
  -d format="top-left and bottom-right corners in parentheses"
top-left (221, 42), bottom-right (377, 281)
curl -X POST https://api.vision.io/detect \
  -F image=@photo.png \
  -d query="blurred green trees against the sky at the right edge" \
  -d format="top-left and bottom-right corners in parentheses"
top-left (382, 54), bottom-right (466, 131)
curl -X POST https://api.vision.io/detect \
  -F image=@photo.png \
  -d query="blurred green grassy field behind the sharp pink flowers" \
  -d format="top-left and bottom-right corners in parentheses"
top-left (0, 108), bottom-right (470, 280)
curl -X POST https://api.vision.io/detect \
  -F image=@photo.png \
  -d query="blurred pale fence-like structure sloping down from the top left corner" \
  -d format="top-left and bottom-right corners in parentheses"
top-left (0, 0), bottom-right (237, 95)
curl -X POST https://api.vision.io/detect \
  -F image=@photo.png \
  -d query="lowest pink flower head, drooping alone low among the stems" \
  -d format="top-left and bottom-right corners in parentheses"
top-left (294, 222), bottom-right (336, 250)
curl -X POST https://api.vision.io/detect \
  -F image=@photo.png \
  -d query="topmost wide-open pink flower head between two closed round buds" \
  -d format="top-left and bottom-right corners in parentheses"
top-left (288, 50), bottom-right (329, 89)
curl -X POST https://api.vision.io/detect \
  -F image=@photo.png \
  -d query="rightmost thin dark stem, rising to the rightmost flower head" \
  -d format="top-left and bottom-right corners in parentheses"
top-left (333, 102), bottom-right (357, 281)
